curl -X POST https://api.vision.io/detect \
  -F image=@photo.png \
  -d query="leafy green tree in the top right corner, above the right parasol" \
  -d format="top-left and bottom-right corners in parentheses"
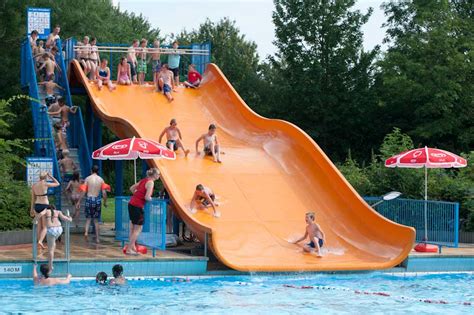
top-left (379, 0), bottom-right (474, 152)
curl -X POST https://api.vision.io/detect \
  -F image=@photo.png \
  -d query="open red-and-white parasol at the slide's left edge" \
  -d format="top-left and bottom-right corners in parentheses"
top-left (92, 137), bottom-right (176, 182)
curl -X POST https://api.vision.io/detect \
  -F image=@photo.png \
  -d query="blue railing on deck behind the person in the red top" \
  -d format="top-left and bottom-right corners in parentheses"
top-left (115, 197), bottom-right (167, 250)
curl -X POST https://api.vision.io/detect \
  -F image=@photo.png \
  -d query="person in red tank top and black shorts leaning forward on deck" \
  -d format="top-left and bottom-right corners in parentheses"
top-left (125, 168), bottom-right (160, 255)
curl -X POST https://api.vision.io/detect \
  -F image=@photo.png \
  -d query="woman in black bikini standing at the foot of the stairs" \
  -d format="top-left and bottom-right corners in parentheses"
top-left (30, 172), bottom-right (59, 248)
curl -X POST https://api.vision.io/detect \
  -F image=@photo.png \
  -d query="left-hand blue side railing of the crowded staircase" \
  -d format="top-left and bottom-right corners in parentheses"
top-left (20, 39), bottom-right (61, 208)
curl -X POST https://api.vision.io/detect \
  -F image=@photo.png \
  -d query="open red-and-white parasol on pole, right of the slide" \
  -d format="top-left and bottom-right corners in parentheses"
top-left (385, 147), bottom-right (467, 240)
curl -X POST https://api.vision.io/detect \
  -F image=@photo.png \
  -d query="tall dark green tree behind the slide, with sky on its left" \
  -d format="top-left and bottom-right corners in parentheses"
top-left (273, 0), bottom-right (383, 160)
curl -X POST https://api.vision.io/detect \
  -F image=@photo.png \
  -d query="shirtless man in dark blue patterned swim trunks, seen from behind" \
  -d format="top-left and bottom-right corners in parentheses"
top-left (84, 165), bottom-right (107, 244)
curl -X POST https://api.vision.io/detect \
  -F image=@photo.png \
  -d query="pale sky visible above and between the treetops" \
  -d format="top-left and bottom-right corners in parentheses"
top-left (113, 0), bottom-right (385, 59)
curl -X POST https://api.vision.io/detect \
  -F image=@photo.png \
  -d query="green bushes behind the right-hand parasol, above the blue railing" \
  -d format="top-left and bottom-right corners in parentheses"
top-left (339, 129), bottom-right (474, 231)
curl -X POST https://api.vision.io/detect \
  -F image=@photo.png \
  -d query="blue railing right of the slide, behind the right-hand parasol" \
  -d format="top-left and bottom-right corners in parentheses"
top-left (364, 197), bottom-right (459, 247)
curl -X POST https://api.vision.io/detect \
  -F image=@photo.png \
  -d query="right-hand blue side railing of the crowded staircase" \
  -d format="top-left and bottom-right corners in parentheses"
top-left (56, 39), bottom-right (92, 178)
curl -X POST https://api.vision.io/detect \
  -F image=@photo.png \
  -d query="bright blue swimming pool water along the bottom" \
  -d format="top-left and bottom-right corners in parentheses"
top-left (0, 273), bottom-right (474, 315)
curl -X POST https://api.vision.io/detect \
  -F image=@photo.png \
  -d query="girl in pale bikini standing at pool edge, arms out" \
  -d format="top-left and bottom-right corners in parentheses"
top-left (36, 205), bottom-right (72, 273)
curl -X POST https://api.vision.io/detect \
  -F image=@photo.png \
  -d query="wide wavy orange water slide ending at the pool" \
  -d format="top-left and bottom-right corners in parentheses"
top-left (69, 61), bottom-right (415, 272)
